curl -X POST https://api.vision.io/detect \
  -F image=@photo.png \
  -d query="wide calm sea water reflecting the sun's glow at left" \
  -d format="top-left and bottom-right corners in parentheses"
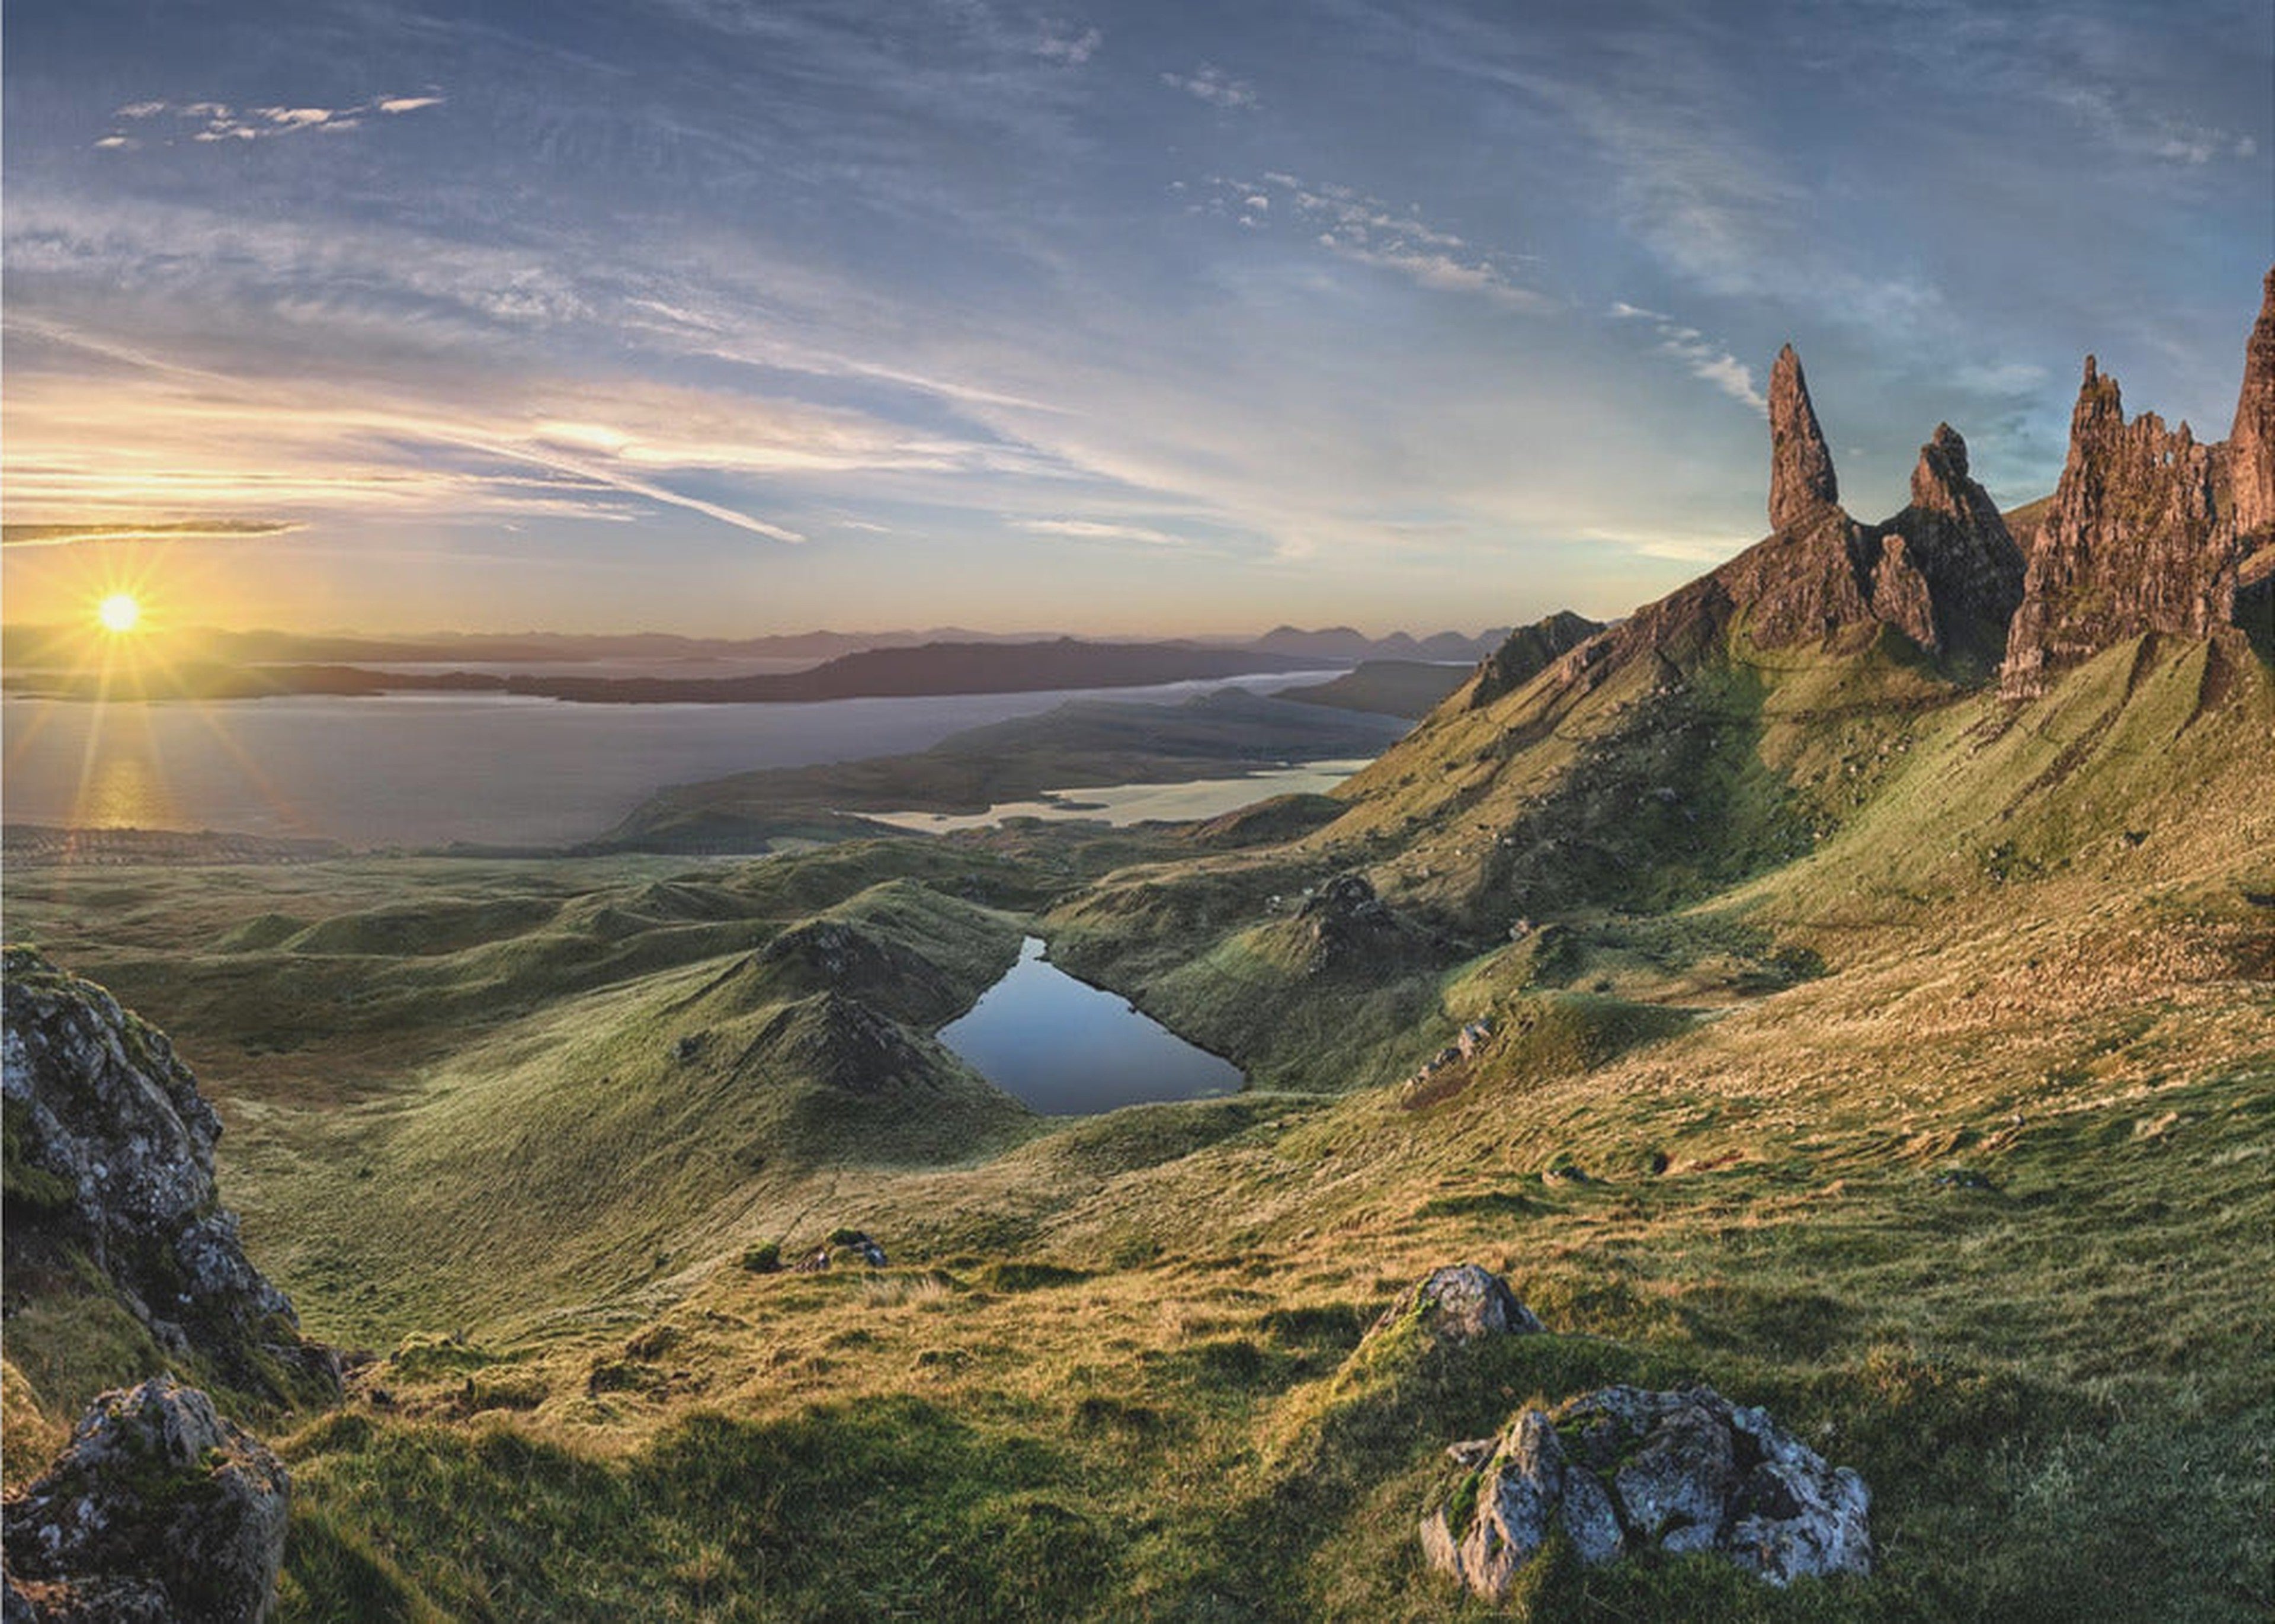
top-left (0, 671), bottom-right (1322, 846)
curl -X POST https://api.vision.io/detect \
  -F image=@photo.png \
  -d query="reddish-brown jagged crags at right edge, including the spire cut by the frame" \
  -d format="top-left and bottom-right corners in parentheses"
top-left (2000, 271), bottom-right (2275, 699)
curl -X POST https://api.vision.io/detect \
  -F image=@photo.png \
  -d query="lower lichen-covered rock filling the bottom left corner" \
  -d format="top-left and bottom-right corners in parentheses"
top-left (7, 1376), bottom-right (291, 1624)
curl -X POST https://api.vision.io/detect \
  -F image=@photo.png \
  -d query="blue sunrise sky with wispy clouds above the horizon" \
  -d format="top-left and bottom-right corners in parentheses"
top-left (0, 0), bottom-right (2275, 635)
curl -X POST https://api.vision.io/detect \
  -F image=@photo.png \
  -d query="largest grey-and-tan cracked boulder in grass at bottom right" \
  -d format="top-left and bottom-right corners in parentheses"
top-left (1422, 1388), bottom-right (1872, 1601)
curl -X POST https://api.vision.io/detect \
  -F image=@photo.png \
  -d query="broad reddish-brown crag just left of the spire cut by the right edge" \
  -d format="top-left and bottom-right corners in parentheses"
top-left (2000, 355), bottom-right (2241, 699)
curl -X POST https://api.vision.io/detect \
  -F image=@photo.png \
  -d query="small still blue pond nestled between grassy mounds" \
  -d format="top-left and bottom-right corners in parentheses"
top-left (940, 937), bottom-right (1247, 1117)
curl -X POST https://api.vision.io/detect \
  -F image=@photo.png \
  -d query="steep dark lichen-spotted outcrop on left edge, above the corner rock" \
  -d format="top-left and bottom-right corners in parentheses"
top-left (0, 946), bottom-right (339, 1399)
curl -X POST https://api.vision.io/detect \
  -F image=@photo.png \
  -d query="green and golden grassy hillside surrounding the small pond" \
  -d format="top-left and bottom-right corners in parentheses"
top-left (9, 628), bottom-right (2275, 1619)
